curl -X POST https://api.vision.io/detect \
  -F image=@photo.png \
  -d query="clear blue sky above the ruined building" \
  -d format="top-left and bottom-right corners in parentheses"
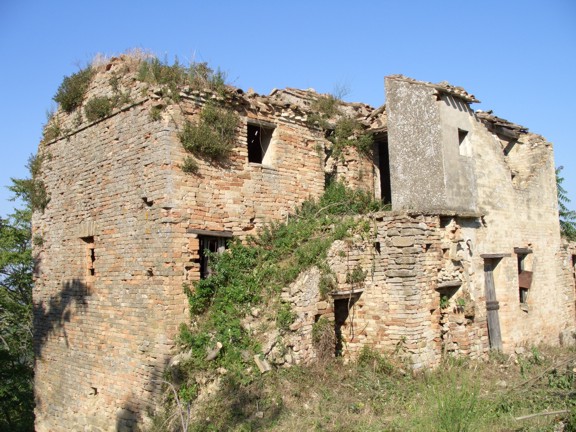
top-left (0, 0), bottom-right (576, 215)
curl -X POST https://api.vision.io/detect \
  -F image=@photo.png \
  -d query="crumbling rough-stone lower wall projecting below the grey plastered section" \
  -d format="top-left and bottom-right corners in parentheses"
top-left (282, 212), bottom-right (488, 369)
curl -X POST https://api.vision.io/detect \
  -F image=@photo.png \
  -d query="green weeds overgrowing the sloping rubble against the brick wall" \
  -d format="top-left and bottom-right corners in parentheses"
top-left (163, 183), bottom-right (388, 426)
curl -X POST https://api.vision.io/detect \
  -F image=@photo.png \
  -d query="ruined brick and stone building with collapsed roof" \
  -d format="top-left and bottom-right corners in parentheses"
top-left (33, 59), bottom-right (576, 431)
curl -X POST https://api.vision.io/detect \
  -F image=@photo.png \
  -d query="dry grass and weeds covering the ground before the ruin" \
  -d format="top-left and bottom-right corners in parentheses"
top-left (155, 342), bottom-right (576, 432)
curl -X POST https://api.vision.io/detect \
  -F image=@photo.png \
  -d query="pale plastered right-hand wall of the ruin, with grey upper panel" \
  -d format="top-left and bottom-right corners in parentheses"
top-left (386, 76), bottom-right (573, 351)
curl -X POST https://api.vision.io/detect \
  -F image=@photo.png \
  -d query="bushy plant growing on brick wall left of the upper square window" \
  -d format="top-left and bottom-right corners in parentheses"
top-left (180, 103), bottom-right (240, 172)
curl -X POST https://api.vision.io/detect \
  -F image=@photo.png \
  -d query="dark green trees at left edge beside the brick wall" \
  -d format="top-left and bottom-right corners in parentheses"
top-left (0, 159), bottom-right (34, 431)
